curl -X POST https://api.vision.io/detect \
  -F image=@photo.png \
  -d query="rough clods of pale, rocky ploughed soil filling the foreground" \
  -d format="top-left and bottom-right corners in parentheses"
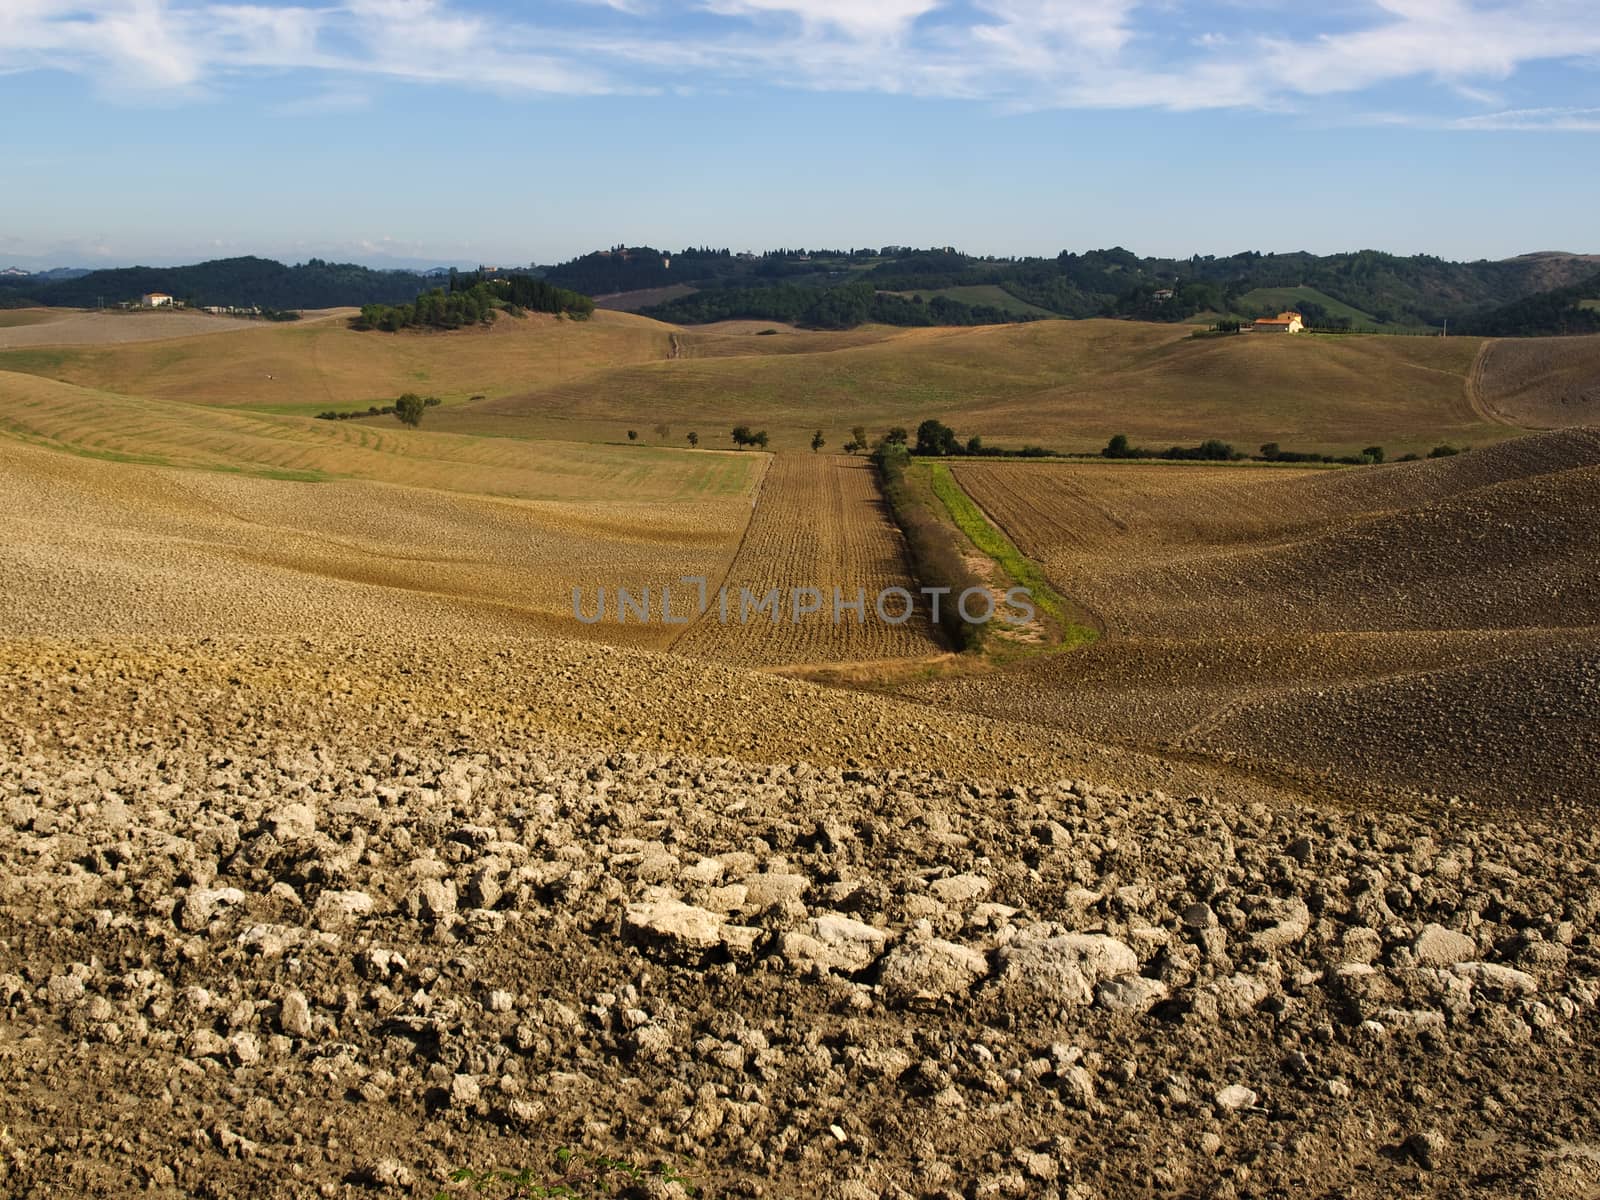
top-left (0, 662), bottom-right (1600, 1200)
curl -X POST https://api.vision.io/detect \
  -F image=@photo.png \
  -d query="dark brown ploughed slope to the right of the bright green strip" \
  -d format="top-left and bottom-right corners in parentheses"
top-left (914, 430), bottom-right (1600, 803)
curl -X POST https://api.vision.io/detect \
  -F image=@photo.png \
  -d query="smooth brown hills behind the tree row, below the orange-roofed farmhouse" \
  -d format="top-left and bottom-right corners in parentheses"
top-left (422, 320), bottom-right (1518, 456)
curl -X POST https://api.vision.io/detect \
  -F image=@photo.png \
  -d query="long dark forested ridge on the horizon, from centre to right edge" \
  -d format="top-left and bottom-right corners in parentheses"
top-left (546, 246), bottom-right (1595, 328)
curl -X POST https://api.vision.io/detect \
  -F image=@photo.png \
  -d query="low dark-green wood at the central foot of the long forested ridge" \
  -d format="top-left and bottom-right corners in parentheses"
top-left (642, 282), bottom-right (1018, 330)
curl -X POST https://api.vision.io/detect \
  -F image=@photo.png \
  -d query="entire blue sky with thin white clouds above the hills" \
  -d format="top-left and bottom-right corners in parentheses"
top-left (0, 0), bottom-right (1600, 266)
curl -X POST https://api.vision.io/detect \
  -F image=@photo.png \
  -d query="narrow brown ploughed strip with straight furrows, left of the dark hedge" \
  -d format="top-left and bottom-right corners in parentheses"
top-left (674, 454), bottom-right (942, 667)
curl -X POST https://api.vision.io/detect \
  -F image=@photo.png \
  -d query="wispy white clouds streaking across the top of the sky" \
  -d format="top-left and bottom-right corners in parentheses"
top-left (0, 0), bottom-right (1600, 131)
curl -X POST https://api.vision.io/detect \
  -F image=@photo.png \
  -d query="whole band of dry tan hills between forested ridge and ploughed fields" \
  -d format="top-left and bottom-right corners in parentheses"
top-left (0, 312), bottom-right (1517, 456)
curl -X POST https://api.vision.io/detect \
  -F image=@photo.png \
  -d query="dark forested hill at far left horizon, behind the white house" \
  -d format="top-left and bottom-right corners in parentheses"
top-left (0, 258), bottom-right (438, 309)
